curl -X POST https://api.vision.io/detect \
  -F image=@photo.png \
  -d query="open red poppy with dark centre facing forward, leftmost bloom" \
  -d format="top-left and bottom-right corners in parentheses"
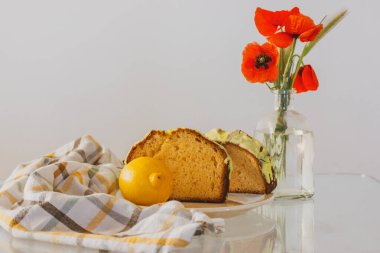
top-left (241, 42), bottom-right (279, 83)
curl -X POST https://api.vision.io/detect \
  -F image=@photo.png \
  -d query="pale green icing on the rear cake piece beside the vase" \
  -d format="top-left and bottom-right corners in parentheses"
top-left (205, 128), bottom-right (274, 184)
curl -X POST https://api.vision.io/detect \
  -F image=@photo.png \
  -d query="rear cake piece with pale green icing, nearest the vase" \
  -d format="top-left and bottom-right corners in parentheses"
top-left (206, 129), bottom-right (277, 194)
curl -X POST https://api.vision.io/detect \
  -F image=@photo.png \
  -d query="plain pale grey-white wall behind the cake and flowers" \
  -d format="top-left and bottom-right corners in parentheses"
top-left (0, 0), bottom-right (380, 181)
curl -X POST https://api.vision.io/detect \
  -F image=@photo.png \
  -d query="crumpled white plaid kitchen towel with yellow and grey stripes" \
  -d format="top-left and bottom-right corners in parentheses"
top-left (0, 135), bottom-right (224, 252)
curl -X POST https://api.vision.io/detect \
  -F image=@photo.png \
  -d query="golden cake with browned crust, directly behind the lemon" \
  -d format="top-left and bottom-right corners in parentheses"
top-left (125, 128), bottom-right (230, 202)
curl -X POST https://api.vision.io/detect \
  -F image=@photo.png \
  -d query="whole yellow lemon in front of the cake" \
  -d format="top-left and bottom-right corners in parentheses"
top-left (119, 157), bottom-right (173, 206)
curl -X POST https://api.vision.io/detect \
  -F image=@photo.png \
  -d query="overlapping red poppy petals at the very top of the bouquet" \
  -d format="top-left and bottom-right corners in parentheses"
top-left (255, 7), bottom-right (323, 48)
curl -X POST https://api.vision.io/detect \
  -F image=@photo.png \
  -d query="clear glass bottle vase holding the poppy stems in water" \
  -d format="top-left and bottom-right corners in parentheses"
top-left (254, 90), bottom-right (314, 198)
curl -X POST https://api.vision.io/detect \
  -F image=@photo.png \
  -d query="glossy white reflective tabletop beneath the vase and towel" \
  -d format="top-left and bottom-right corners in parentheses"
top-left (0, 174), bottom-right (380, 253)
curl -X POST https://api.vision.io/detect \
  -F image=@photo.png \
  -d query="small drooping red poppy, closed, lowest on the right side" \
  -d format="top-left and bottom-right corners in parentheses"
top-left (293, 65), bottom-right (319, 93)
